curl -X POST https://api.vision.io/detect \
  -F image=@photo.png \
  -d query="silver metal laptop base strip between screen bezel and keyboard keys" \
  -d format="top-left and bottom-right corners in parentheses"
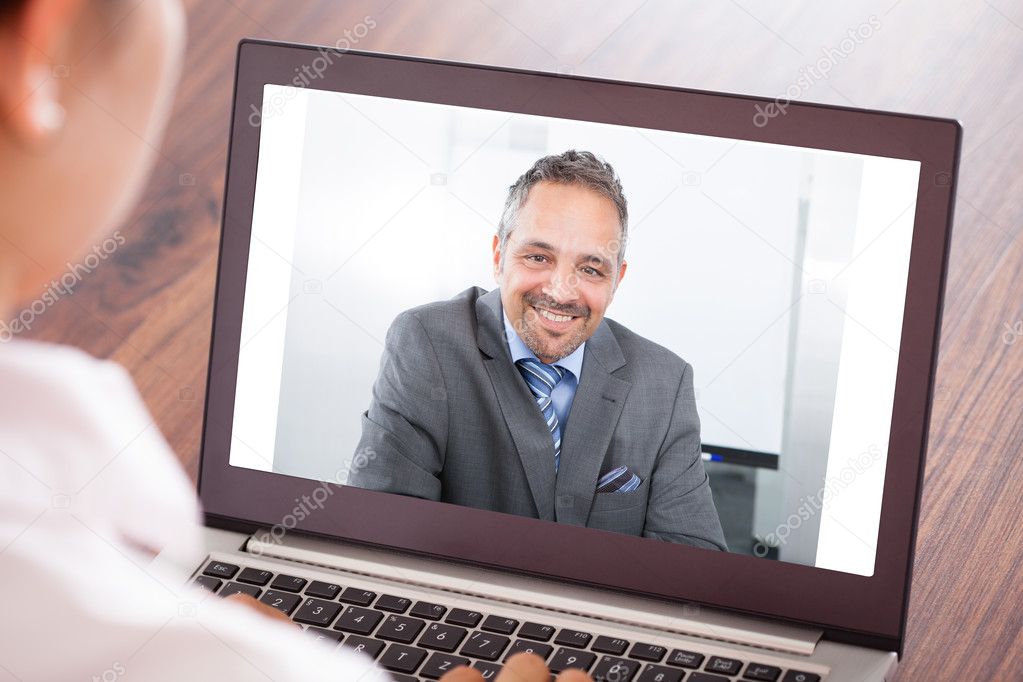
top-left (188, 529), bottom-right (897, 680)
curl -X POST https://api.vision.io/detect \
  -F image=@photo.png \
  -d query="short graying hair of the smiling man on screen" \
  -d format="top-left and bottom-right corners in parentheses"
top-left (497, 149), bottom-right (629, 266)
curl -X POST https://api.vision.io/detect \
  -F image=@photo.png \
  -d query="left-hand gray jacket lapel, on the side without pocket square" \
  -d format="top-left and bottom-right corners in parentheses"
top-left (476, 288), bottom-right (556, 520)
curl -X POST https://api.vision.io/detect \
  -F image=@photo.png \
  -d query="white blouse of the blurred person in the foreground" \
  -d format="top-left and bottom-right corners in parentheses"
top-left (0, 339), bottom-right (389, 682)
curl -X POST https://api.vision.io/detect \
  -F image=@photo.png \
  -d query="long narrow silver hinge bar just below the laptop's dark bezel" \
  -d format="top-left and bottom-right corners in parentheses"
top-left (246, 532), bottom-right (822, 655)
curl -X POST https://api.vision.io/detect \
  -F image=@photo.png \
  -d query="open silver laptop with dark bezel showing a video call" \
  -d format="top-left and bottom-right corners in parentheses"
top-left (173, 40), bottom-right (962, 682)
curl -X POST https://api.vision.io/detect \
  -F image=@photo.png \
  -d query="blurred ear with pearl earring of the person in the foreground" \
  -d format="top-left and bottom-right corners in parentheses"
top-left (0, 0), bottom-right (83, 148)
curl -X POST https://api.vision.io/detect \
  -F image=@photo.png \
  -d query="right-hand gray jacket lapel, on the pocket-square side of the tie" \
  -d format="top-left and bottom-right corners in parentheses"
top-left (557, 322), bottom-right (632, 526)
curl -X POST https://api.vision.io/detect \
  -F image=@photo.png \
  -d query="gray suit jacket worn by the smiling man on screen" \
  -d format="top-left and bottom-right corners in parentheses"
top-left (349, 287), bottom-right (725, 549)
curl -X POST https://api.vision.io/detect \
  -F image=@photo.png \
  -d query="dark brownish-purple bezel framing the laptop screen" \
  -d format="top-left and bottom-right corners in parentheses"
top-left (199, 40), bottom-right (962, 650)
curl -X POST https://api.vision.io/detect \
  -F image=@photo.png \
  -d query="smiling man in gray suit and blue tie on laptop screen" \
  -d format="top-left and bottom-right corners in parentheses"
top-left (349, 150), bottom-right (725, 549)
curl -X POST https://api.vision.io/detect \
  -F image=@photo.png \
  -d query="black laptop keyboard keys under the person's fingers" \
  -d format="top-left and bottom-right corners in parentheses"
top-left (194, 560), bottom-right (820, 682)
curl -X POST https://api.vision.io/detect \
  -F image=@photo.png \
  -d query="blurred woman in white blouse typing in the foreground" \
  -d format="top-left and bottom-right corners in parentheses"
top-left (0, 0), bottom-right (589, 682)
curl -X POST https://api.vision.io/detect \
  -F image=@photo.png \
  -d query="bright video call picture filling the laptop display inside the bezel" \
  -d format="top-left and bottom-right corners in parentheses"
top-left (230, 85), bottom-right (920, 576)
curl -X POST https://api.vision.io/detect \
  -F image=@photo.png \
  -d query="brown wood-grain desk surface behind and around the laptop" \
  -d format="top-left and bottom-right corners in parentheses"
top-left (29, 0), bottom-right (1023, 680)
